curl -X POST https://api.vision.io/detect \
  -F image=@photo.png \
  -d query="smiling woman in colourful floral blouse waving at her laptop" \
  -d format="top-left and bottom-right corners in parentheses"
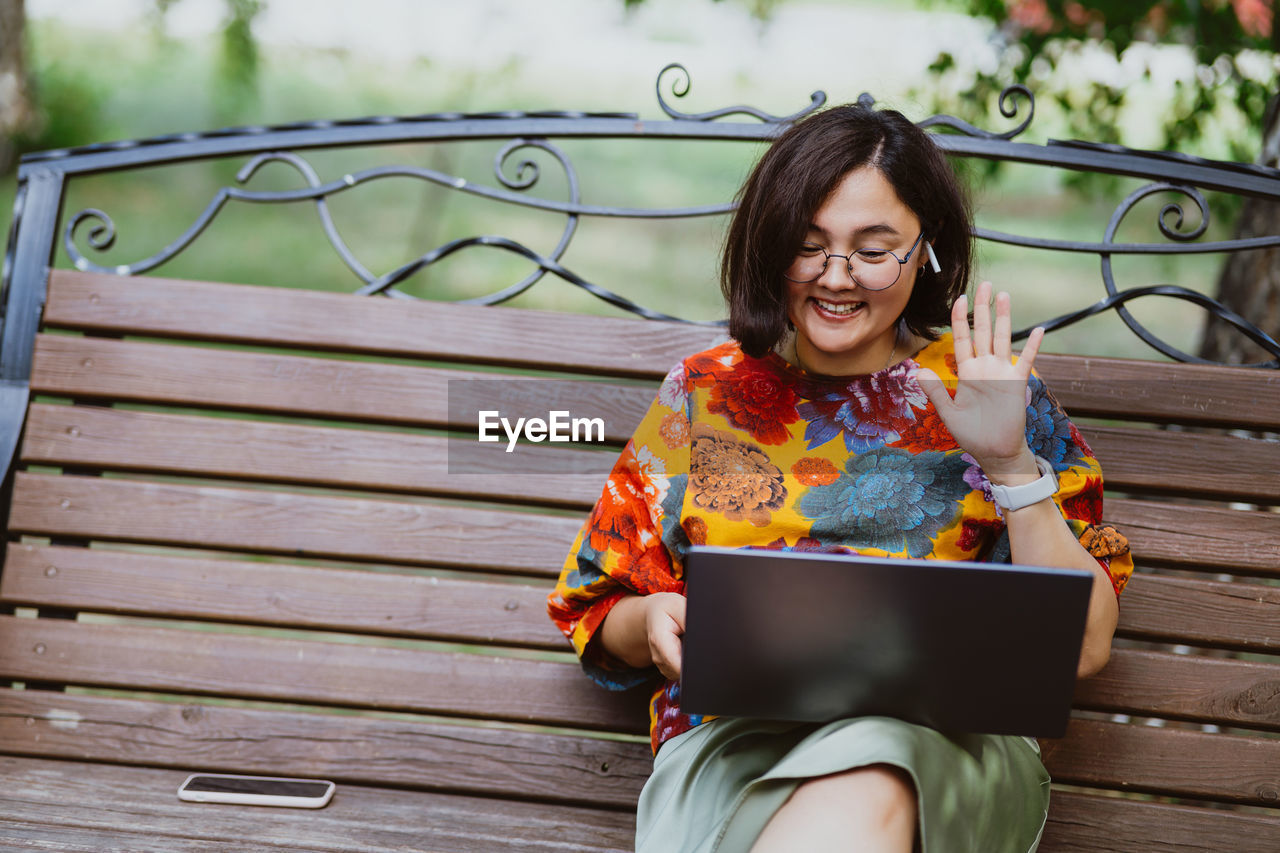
top-left (549, 105), bottom-right (1133, 853)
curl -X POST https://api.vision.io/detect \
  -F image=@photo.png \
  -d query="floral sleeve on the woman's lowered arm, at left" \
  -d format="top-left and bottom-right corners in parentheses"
top-left (547, 365), bottom-right (690, 690)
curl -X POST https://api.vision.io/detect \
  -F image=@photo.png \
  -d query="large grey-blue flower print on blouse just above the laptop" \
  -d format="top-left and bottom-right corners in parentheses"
top-left (799, 447), bottom-right (969, 557)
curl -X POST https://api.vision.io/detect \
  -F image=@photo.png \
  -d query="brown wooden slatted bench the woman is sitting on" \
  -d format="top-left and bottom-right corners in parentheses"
top-left (0, 74), bottom-right (1280, 853)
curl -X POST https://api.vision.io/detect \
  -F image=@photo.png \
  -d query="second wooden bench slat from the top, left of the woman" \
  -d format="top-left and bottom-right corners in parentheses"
top-left (31, 334), bottom-right (657, 442)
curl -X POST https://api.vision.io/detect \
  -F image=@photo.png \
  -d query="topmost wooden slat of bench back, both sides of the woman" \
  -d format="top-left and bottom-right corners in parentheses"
top-left (45, 270), bottom-right (1280, 429)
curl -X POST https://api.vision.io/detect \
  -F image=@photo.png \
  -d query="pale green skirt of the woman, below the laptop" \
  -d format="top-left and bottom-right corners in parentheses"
top-left (636, 717), bottom-right (1050, 853)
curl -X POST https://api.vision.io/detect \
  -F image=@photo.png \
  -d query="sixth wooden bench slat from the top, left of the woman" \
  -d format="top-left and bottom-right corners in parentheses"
top-left (0, 616), bottom-right (648, 734)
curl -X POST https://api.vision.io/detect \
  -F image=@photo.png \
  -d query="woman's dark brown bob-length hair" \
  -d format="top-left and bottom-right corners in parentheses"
top-left (721, 104), bottom-right (973, 357)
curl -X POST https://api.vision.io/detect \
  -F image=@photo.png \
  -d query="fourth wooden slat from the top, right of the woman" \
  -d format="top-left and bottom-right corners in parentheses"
top-left (1119, 575), bottom-right (1280, 652)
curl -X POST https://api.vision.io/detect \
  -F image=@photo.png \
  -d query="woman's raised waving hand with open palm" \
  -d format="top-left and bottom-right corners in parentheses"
top-left (916, 282), bottom-right (1044, 483)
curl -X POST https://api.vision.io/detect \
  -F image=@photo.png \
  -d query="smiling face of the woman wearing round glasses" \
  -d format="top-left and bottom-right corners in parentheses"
top-left (786, 167), bottom-right (925, 377)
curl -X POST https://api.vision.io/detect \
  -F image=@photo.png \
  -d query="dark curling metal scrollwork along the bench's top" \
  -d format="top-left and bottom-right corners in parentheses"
top-left (45, 63), bottom-right (1280, 358)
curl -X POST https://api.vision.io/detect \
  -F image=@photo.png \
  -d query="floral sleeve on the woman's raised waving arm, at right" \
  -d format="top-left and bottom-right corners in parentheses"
top-left (1006, 375), bottom-right (1133, 596)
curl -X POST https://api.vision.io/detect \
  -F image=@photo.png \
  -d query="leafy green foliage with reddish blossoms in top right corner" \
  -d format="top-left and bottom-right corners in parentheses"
top-left (920, 0), bottom-right (1280, 161)
